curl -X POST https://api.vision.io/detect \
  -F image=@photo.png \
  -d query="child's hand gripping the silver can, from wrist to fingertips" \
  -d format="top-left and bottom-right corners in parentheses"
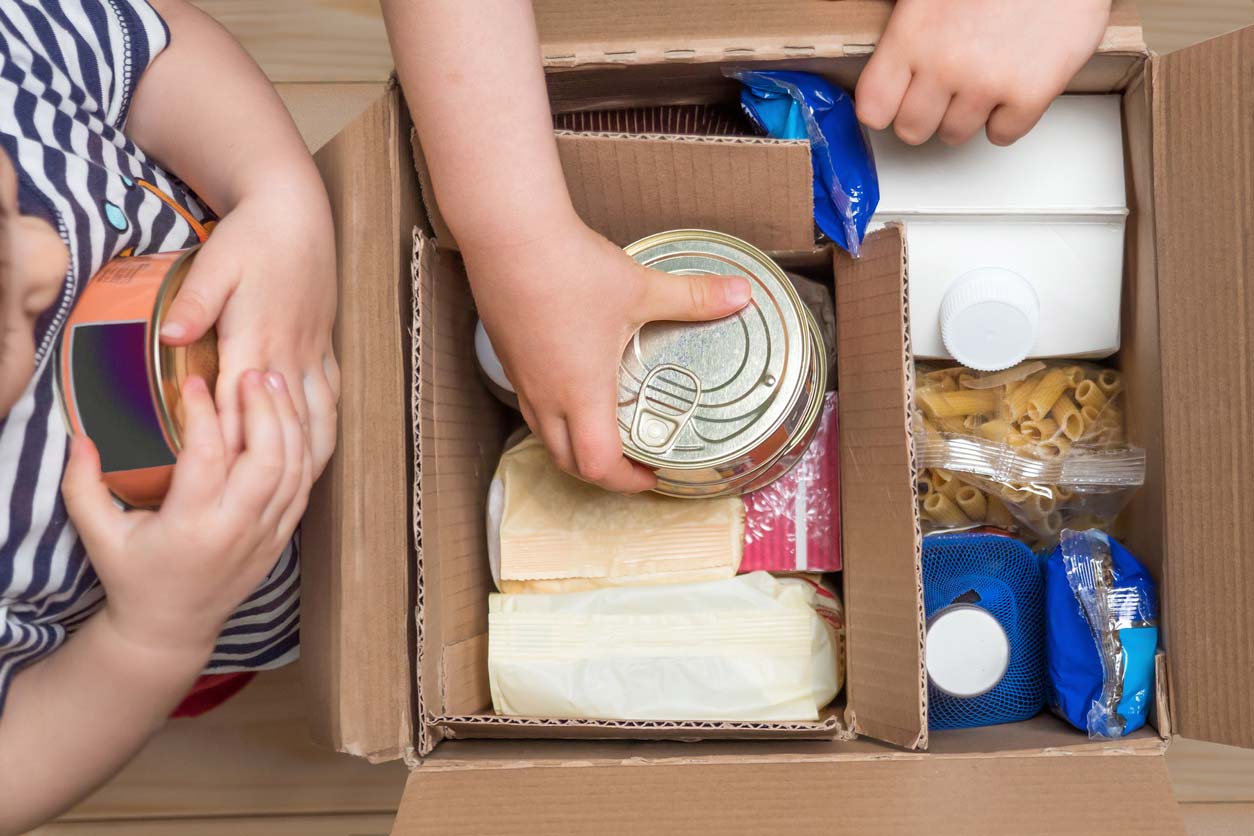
top-left (463, 218), bottom-right (750, 493)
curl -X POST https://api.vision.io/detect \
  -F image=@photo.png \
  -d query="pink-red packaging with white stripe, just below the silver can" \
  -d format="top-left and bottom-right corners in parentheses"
top-left (740, 392), bottom-right (840, 572)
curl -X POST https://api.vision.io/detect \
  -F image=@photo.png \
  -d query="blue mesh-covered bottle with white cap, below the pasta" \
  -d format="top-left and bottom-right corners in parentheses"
top-left (923, 533), bottom-right (1047, 729)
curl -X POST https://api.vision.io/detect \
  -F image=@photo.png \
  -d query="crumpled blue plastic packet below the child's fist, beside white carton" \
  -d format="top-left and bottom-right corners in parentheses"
top-left (727, 70), bottom-right (879, 256)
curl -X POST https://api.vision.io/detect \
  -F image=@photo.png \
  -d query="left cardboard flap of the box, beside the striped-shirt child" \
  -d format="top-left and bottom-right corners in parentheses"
top-left (301, 89), bottom-right (418, 761)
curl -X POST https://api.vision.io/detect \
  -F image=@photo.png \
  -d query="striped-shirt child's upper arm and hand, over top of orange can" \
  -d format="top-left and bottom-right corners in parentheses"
top-left (125, 0), bottom-right (339, 471)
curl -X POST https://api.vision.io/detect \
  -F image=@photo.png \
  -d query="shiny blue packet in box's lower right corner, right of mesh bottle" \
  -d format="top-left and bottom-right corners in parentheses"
top-left (1045, 529), bottom-right (1159, 738)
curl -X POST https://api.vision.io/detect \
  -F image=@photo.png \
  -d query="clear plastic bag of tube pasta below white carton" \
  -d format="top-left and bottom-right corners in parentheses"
top-left (914, 360), bottom-right (1145, 548)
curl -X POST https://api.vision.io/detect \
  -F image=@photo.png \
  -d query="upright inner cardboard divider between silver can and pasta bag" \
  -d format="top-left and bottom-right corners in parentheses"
top-left (835, 227), bottom-right (927, 748)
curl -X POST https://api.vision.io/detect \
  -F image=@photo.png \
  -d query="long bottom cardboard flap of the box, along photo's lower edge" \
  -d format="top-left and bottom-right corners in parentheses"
top-left (393, 752), bottom-right (1185, 836)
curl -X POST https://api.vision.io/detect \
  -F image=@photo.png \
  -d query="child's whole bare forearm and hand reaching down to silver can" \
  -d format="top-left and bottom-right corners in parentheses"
top-left (382, 0), bottom-right (749, 490)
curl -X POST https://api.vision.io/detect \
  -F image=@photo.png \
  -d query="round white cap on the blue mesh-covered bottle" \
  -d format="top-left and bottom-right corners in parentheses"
top-left (924, 604), bottom-right (1011, 697)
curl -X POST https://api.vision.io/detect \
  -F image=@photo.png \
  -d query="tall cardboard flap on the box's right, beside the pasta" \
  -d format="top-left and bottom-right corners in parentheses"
top-left (1152, 29), bottom-right (1254, 747)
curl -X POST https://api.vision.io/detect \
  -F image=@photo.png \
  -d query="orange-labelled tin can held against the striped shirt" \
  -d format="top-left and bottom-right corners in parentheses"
top-left (56, 248), bottom-right (218, 508)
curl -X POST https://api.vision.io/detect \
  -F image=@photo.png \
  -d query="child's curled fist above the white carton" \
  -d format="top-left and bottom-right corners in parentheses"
top-left (854, 0), bottom-right (1110, 145)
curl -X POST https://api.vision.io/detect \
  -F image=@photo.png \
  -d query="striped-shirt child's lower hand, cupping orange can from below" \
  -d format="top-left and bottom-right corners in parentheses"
top-left (61, 371), bottom-right (314, 658)
